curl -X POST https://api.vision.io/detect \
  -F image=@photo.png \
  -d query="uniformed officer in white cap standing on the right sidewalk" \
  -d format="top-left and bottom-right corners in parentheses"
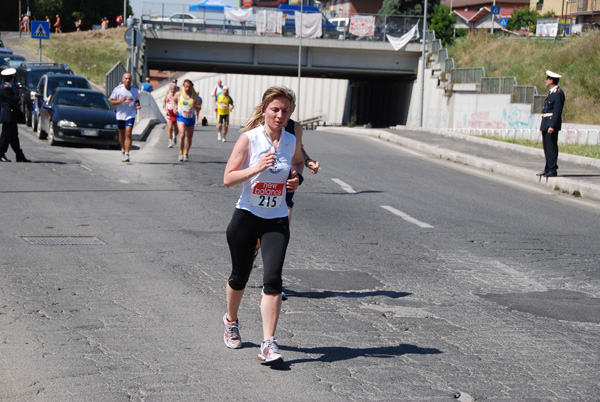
top-left (538, 70), bottom-right (565, 177)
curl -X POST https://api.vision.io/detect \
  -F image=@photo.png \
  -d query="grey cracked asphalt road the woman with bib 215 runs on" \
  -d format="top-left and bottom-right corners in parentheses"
top-left (0, 126), bottom-right (600, 401)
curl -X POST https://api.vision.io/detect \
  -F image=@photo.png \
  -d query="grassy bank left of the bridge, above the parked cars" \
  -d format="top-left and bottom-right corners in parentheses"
top-left (19, 28), bottom-right (128, 86)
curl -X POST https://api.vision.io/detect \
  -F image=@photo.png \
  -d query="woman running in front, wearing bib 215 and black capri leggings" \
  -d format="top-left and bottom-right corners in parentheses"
top-left (223, 87), bottom-right (301, 364)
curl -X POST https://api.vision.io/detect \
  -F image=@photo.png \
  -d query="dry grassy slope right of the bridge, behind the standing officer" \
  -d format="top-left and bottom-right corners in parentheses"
top-left (448, 32), bottom-right (600, 124)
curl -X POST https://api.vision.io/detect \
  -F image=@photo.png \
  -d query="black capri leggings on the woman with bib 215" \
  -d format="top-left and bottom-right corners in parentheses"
top-left (227, 209), bottom-right (290, 295)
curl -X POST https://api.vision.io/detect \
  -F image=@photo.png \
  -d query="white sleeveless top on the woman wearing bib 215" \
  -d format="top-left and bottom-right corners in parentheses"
top-left (236, 126), bottom-right (296, 219)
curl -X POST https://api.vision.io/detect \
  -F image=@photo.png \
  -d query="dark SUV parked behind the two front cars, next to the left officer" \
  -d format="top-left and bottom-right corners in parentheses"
top-left (15, 62), bottom-right (73, 126)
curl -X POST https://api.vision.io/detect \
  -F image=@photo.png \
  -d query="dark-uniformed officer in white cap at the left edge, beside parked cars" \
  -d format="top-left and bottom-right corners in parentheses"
top-left (0, 68), bottom-right (31, 162)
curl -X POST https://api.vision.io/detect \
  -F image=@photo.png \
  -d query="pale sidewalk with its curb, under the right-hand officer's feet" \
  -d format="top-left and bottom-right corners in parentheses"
top-left (317, 127), bottom-right (600, 201)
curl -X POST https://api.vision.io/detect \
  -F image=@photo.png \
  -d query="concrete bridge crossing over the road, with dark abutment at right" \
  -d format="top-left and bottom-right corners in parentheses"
top-left (137, 30), bottom-right (422, 126)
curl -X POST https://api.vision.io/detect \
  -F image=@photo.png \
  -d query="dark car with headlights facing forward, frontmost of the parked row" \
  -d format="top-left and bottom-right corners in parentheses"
top-left (37, 87), bottom-right (120, 149)
